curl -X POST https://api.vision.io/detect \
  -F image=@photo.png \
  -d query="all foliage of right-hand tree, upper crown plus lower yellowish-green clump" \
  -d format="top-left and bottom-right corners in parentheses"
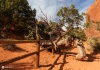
top-left (57, 4), bottom-right (86, 40)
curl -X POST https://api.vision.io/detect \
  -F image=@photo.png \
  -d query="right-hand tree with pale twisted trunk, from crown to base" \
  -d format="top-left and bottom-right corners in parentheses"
top-left (57, 5), bottom-right (86, 60)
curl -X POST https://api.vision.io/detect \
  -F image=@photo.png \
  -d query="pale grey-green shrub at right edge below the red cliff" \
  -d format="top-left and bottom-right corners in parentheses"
top-left (88, 37), bottom-right (100, 52)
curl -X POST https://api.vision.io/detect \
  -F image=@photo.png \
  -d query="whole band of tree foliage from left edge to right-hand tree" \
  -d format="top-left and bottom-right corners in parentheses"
top-left (0, 0), bottom-right (86, 50)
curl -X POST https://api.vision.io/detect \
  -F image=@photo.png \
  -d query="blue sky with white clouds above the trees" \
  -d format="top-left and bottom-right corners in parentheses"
top-left (28, 0), bottom-right (94, 21)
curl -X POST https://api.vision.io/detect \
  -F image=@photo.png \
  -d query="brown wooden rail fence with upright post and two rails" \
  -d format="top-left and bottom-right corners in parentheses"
top-left (0, 36), bottom-right (50, 68)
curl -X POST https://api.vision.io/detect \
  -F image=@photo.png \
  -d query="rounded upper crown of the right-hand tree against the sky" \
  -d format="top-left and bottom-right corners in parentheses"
top-left (57, 4), bottom-right (83, 27)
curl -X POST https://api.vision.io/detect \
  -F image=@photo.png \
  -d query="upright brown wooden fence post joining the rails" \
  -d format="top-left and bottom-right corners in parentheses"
top-left (35, 35), bottom-right (40, 68)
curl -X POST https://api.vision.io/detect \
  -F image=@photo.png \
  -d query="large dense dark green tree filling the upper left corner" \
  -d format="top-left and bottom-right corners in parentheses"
top-left (0, 0), bottom-right (36, 38)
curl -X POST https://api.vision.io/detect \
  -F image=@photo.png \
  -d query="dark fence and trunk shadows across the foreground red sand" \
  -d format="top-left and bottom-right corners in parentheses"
top-left (2, 52), bottom-right (100, 70)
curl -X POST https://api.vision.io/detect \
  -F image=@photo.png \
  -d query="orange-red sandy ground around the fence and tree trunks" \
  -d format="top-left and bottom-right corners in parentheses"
top-left (0, 43), bottom-right (100, 70)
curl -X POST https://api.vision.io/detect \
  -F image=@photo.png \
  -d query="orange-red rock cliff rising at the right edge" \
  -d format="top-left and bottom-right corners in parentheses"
top-left (85, 0), bottom-right (100, 38)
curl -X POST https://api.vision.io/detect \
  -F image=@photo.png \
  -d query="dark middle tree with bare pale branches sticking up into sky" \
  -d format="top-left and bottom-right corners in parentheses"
top-left (38, 9), bottom-right (63, 41)
